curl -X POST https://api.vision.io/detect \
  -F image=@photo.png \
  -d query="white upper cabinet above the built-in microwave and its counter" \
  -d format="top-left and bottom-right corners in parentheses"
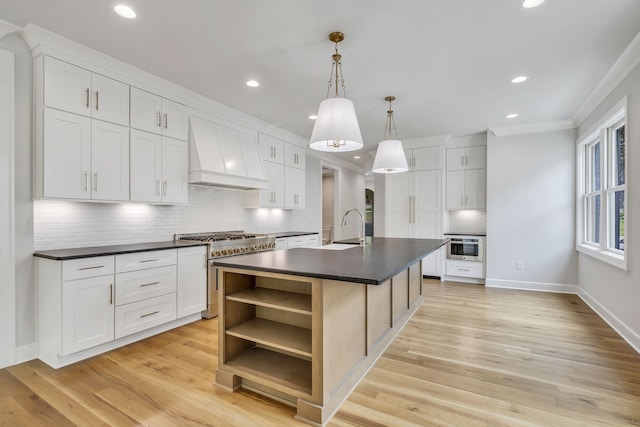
top-left (446, 145), bottom-right (487, 210)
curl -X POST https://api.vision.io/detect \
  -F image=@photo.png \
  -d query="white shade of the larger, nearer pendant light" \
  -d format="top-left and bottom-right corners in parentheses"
top-left (309, 98), bottom-right (363, 152)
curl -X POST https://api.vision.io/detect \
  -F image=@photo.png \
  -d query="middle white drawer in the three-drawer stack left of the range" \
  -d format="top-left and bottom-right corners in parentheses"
top-left (116, 265), bottom-right (177, 305)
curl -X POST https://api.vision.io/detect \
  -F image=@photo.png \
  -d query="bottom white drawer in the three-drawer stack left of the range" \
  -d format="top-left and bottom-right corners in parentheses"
top-left (115, 293), bottom-right (176, 338)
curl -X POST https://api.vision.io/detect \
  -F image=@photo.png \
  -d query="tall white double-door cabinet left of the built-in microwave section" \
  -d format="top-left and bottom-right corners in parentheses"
top-left (384, 147), bottom-right (442, 276)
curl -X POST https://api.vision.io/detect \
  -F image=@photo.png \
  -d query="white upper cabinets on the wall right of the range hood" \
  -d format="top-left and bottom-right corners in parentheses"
top-left (244, 133), bottom-right (306, 209)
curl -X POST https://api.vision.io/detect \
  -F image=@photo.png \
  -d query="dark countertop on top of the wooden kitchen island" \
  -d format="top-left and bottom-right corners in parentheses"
top-left (214, 237), bottom-right (447, 285)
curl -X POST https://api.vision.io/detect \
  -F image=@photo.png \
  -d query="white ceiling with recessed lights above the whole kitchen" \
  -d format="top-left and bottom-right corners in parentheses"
top-left (0, 0), bottom-right (640, 169)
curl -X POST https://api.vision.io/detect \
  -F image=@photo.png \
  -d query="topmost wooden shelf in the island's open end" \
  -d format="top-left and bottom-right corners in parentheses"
top-left (227, 288), bottom-right (311, 316)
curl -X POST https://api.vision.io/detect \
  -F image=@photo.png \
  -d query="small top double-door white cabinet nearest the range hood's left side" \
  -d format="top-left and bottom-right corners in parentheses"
top-left (131, 87), bottom-right (189, 141)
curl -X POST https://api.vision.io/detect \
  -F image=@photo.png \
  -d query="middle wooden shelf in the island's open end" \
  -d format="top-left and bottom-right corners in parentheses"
top-left (226, 317), bottom-right (311, 357)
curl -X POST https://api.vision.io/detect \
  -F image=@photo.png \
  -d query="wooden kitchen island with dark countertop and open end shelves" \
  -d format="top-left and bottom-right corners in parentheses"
top-left (214, 238), bottom-right (446, 425)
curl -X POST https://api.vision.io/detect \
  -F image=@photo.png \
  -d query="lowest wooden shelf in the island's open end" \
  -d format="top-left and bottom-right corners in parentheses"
top-left (225, 347), bottom-right (311, 395)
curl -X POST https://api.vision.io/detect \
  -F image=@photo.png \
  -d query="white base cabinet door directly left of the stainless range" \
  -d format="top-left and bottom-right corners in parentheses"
top-left (177, 246), bottom-right (207, 318)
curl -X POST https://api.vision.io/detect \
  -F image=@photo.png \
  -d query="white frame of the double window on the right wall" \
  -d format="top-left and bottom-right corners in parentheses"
top-left (576, 97), bottom-right (630, 271)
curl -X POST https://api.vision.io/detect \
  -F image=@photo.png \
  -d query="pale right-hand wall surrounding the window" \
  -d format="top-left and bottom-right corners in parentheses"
top-left (578, 61), bottom-right (640, 351)
